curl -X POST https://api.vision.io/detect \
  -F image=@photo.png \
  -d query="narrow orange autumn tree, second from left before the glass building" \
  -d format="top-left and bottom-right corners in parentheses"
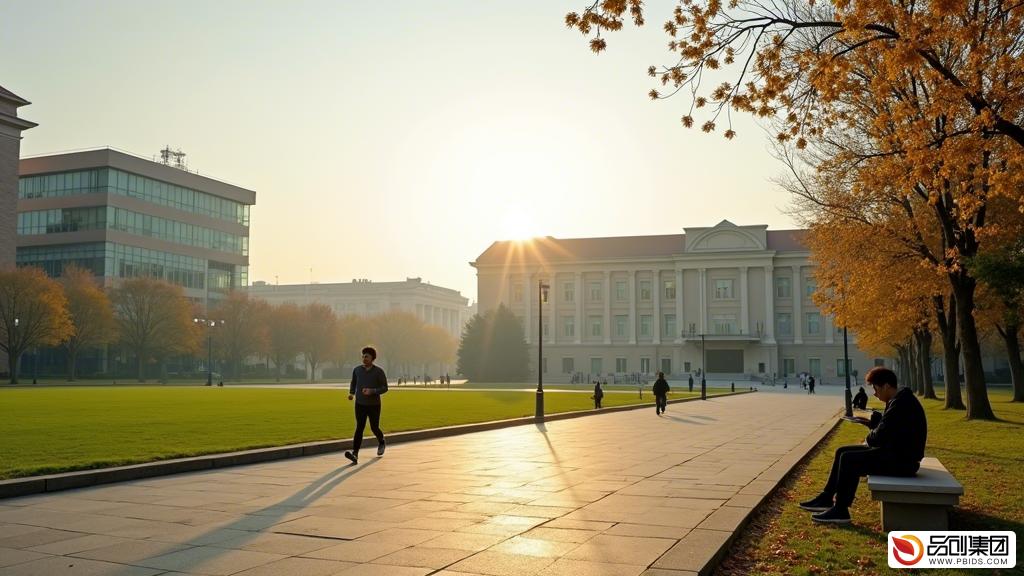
top-left (58, 264), bottom-right (117, 381)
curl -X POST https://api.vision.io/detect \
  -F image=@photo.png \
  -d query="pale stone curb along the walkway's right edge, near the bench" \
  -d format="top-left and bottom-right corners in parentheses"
top-left (644, 413), bottom-right (840, 576)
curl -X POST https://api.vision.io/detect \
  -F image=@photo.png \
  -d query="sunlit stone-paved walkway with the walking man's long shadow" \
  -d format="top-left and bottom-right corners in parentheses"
top-left (0, 387), bottom-right (841, 576)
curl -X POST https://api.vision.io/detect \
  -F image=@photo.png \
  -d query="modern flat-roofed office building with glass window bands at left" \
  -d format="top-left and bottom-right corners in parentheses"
top-left (17, 149), bottom-right (256, 303)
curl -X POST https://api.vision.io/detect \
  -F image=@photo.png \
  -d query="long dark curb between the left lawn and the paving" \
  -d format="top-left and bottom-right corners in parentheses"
top-left (0, 390), bottom-right (752, 499)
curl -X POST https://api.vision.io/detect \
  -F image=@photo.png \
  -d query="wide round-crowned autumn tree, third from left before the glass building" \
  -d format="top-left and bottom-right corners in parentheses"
top-left (111, 278), bottom-right (203, 382)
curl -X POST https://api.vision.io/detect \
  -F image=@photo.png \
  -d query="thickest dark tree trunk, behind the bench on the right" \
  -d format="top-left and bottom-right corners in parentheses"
top-left (949, 272), bottom-right (995, 420)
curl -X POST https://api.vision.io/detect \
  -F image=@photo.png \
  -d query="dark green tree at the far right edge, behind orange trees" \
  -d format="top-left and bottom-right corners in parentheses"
top-left (971, 238), bottom-right (1024, 402)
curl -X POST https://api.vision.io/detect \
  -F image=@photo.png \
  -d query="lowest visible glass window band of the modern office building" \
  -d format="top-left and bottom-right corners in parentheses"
top-left (17, 242), bottom-right (249, 292)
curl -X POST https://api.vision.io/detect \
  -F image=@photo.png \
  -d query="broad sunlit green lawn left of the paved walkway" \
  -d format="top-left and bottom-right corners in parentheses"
top-left (0, 386), bottom-right (720, 479)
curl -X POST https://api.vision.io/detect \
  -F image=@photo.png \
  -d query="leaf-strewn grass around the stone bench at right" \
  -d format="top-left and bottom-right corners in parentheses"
top-left (717, 390), bottom-right (1024, 576)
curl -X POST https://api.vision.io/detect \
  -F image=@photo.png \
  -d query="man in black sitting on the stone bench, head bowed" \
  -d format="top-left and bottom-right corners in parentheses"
top-left (800, 366), bottom-right (928, 524)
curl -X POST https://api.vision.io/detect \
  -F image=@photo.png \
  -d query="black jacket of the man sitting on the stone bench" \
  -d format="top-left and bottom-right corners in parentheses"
top-left (867, 388), bottom-right (928, 463)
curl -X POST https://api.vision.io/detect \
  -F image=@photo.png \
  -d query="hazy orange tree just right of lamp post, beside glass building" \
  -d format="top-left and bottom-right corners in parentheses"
top-left (211, 291), bottom-right (270, 378)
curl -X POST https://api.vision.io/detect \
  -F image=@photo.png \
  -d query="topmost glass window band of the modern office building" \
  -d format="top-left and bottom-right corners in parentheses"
top-left (17, 168), bottom-right (249, 225)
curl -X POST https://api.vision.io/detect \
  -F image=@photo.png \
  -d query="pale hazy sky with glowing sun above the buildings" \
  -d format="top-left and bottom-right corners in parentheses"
top-left (0, 0), bottom-right (794, 300)
